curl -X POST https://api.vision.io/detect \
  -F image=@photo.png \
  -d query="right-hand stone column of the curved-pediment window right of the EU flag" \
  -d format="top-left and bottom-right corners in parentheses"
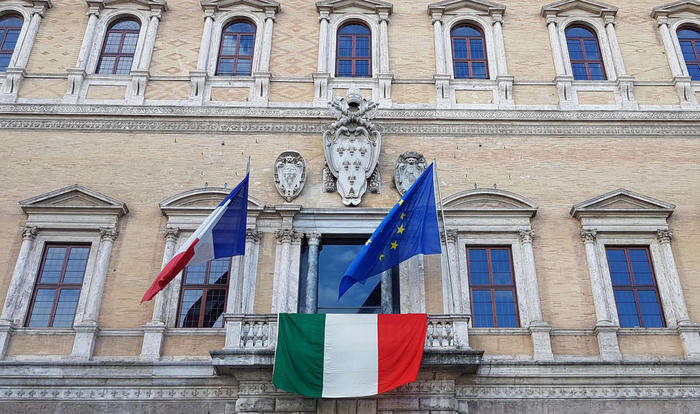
top-left (519, 229), bottom-right (554, 361)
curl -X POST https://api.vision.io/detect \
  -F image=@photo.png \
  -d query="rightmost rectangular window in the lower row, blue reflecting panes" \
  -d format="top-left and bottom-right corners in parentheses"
top-left (606, 247), bottom-right (664, 328)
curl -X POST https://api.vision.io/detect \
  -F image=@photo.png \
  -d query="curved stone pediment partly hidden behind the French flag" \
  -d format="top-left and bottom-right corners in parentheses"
top-left (159, 187), bottom-right (263, 215)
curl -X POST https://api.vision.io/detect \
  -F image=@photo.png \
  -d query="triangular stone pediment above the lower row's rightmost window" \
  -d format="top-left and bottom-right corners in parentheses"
top-left (570, 188), bottom-right (676, 217)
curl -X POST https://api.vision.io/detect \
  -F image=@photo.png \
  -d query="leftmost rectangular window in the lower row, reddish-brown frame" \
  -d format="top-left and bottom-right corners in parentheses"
top-left (26, 244), bottom-right (90, 328)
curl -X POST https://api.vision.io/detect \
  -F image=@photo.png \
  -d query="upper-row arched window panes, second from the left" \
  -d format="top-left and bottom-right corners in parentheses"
top-left (96, 18), bottom-right (141, 75)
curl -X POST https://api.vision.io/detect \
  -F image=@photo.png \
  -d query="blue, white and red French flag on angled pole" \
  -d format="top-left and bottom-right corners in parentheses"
top-left (141, 174), bottom-right (248, 303)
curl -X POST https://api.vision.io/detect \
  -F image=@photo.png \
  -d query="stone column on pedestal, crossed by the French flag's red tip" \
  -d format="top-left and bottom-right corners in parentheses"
top-left (141, 227), bottom-right (180, 359)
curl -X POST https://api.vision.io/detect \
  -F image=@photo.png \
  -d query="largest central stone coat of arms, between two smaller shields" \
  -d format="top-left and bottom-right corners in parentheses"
top-left (323, 87), bottom-right (382, 206)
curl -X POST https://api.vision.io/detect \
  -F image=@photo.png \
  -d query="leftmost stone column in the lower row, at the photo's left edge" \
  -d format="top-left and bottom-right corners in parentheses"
top-left (0, 226), bottom-right (39, 359)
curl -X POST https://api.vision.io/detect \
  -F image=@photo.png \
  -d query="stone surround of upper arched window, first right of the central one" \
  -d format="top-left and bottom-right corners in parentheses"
top-left (428, 0), bottom-right (515, 109)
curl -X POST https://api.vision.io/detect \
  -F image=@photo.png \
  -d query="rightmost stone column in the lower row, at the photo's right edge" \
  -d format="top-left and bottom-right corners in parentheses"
top-left (657, 229), bottom-right (700, 358)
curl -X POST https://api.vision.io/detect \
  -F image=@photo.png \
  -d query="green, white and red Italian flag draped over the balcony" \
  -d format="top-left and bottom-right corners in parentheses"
top-left (272, 313), bottom-right (428, 398)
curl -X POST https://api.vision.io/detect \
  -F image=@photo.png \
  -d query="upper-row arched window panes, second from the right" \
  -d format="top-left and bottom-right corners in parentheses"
top-left (566, 26), bottom-right (606, 80)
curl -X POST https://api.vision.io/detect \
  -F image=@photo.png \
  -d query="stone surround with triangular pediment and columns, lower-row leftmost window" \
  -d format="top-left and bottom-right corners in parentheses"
top-left (0, 184), bottom-right (128, 359)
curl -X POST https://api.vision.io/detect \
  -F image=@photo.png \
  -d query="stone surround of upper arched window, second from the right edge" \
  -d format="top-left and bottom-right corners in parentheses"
top-left (541, 0), bottom-right (639, 109)
